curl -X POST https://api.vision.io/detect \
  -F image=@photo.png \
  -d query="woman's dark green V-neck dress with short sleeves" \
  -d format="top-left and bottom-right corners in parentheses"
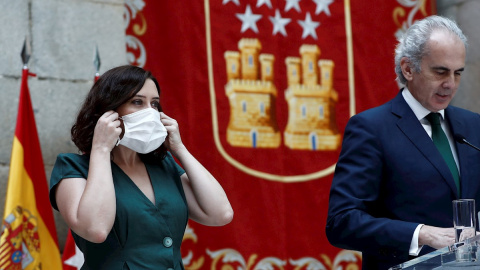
top-left (50, 153), bottom-right (188, 270)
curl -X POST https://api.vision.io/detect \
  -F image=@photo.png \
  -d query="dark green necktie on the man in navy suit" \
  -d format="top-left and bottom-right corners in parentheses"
top-left (426, 113), bottom-right (460, 196)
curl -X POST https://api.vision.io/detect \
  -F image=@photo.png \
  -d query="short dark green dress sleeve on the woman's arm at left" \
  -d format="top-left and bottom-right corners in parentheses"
top-left (49, 154), bottom-right (90, 211)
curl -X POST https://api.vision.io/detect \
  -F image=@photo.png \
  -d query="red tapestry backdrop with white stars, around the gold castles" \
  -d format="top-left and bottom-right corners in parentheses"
top-left (125, 0), bottom-right (435, 269)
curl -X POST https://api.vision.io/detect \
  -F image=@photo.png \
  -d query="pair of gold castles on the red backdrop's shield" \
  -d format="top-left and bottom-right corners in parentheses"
top-left (224, 38), bottom-right (341, 150)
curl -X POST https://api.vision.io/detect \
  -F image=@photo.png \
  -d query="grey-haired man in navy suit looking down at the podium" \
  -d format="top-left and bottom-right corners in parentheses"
top-left (326, 16), bottom-right (480, 269)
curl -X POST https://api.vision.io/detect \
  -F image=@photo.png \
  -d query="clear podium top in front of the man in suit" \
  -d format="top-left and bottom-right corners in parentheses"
top-left (389, 235), bottom-right (480, 270)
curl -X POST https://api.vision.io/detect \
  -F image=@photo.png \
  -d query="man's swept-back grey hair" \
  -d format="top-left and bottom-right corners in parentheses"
top-left (395, 15), bottom-right (467, 84)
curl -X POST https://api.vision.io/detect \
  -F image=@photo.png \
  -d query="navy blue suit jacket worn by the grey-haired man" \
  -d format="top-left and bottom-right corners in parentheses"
top-left (326, 92), bottom-right (480, 269)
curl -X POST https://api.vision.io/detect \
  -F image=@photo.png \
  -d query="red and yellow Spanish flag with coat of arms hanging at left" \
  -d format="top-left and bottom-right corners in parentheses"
top-left (0, 67), bottom-right (62, 270)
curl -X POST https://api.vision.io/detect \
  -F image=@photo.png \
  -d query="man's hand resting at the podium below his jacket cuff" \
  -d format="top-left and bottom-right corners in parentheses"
top-left (418, 225), bottom-right (455, 249)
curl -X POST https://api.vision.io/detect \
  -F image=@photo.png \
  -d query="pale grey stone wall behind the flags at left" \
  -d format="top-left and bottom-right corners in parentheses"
top-left (0, 0), bottom-right (127, 250)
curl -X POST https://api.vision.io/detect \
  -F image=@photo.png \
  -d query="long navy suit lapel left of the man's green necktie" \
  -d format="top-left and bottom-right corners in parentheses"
top-left (392, 92), bottom-right (457, 197)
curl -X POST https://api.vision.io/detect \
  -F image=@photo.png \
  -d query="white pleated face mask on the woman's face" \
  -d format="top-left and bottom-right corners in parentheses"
top-left (117, 108), bottom-right (167, 154)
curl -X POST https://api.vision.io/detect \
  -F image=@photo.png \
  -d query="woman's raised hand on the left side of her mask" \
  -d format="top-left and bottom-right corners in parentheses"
top-left (92, 110), bottom-right (122, 152)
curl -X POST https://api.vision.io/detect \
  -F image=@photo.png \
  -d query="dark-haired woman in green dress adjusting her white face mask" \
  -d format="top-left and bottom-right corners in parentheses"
top-left (50, 66), bottom-right (233, 270)
